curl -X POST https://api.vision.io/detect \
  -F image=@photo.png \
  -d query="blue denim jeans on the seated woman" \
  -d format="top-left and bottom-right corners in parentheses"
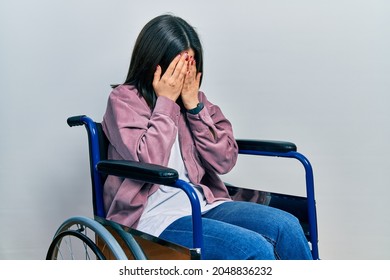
top-left (160, 201), bottom-right (312, 260)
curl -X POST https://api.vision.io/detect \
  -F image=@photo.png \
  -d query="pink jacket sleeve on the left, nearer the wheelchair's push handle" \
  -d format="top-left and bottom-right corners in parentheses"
top-left (103, 86), bottom-right (180, 165)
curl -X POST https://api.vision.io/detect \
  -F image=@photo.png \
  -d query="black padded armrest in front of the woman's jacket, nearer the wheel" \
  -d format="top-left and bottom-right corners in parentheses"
top-left (96, 160), bottom-right (179, 186)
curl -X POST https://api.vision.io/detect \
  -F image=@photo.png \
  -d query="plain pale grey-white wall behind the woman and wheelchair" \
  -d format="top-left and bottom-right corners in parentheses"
top-left (0, 0), bottom-right (390, 259)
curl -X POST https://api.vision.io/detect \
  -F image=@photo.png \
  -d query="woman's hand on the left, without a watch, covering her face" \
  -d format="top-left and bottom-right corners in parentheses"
top-left (152, 53), bottom-right (189, 102)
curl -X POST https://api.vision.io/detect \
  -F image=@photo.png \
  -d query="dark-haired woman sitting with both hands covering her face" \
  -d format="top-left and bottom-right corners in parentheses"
top-left (102, 15), bottom-right (311, 259)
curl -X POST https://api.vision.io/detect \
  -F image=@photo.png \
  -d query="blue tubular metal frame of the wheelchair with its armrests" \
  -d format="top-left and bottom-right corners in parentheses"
top-left (67, 115), bottom-right (319, 259)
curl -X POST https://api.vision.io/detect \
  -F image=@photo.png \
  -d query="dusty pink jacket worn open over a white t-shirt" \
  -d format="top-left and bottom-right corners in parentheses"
top-left (102, 85), bottom-right (238, 227)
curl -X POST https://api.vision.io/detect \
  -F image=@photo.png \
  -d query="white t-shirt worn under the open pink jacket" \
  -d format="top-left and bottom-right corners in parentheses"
top-left (137, 135), bottom-right (225, 236)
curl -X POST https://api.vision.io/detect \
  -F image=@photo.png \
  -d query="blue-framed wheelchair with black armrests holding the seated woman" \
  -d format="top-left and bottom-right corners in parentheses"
top-left (46, 115), bottom-right (319, 260)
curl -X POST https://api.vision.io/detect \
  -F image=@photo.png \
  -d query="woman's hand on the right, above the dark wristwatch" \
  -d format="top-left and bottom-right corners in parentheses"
top-left (181, 57), bottom-right (202, 110)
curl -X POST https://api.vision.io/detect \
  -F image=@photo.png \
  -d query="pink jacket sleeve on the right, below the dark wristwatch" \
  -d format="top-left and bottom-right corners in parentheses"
top-left (187, 92), bottom-right (238, 174)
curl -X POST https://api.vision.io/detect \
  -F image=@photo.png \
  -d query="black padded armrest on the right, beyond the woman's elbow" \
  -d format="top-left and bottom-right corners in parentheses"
top-left (236, 139), bottom-right (297, 153)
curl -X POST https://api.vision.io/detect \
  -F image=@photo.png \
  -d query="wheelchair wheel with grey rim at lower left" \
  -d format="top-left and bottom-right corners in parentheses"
top-left (46, 217), bottom-right (128, 260)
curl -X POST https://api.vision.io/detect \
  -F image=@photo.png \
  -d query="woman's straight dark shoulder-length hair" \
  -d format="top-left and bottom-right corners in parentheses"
top-left (124, 15), bottom-right (203, 108)
